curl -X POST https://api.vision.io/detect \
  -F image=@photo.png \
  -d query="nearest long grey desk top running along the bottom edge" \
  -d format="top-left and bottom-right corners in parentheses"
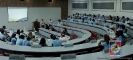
top-left (0, 44), bottom-right (133, 60)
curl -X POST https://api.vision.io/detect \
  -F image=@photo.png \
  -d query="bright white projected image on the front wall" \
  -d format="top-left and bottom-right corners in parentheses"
top-left (8, 7), bottom-right (27, 22)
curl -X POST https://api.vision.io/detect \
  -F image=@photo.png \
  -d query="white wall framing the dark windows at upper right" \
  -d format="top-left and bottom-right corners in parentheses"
top-left (68, 0), bottom-right (133, 18)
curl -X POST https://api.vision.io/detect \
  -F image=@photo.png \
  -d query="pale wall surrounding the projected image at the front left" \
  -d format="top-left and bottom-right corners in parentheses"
top-left (0, 7), bottom-right (61, 31)
